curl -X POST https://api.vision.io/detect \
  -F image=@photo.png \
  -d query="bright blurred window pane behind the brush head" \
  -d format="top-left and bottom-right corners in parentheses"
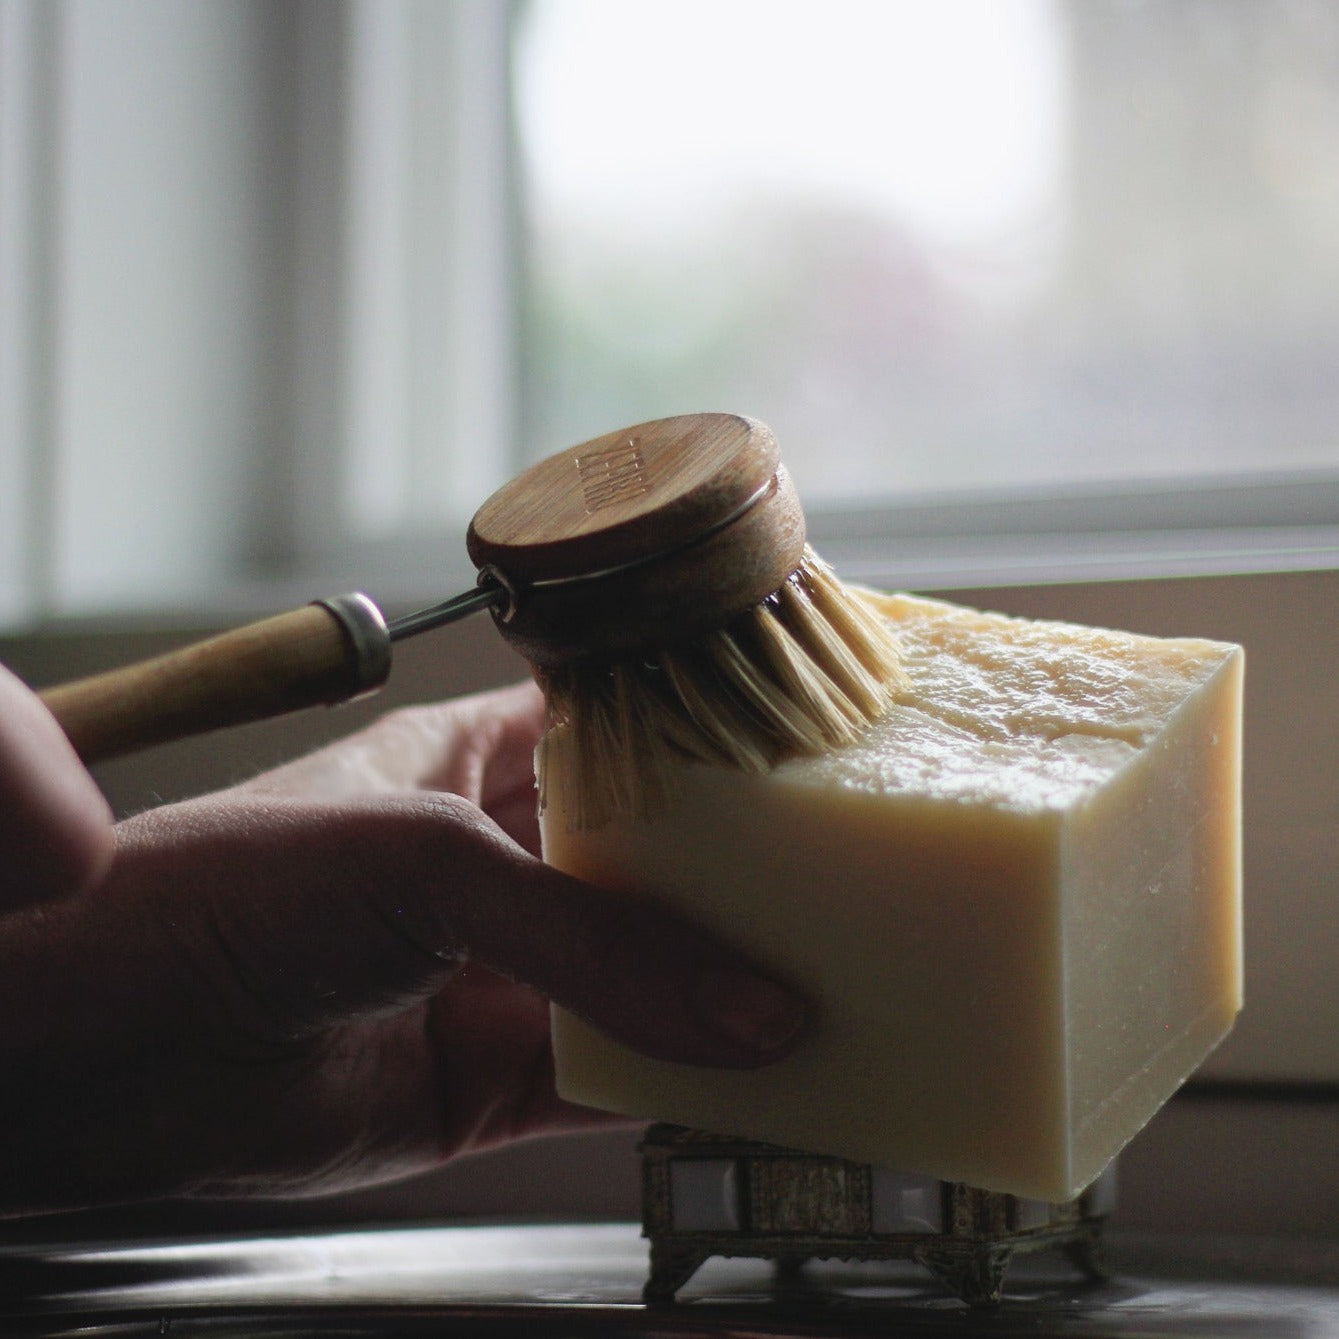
top-left (517, 0), bottom-right (1339, 502)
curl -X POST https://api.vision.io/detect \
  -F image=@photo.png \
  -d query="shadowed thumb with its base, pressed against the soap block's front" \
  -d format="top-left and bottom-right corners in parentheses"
top-left (98, 793), bottom-right (805, 1067)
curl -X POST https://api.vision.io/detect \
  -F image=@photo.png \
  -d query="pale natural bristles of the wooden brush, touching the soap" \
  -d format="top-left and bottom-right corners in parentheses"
top-left (537, 546), bottom-right (904, 829)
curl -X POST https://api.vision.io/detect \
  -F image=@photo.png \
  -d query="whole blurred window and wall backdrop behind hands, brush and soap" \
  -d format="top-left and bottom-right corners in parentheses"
top-left (0, 0), bottom-right (1339, 1235)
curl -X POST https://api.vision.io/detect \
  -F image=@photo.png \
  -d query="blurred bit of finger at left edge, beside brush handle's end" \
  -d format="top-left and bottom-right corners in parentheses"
top-left (0, 665), bottom-right (115, 911)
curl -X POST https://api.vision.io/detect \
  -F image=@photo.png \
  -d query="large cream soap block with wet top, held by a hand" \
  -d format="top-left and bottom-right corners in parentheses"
top-left (544, 596), bottom-right (1243, 1201)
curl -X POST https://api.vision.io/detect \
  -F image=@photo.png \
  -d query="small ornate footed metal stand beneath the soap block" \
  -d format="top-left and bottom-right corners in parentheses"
top-left (641, 1125), bottom-right (1115, 1306)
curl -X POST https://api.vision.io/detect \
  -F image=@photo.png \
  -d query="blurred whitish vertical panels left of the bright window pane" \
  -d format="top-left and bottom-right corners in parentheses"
top-left (0, 0), bottom-right (516, 621)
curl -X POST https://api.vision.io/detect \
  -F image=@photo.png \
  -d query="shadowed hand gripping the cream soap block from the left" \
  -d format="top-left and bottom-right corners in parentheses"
top-left (0, 686), bottom-right (802, 1212)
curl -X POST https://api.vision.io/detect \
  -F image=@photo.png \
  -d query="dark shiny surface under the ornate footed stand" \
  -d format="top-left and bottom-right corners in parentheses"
top-left (0, 1224), bottom-right (1339, 1339)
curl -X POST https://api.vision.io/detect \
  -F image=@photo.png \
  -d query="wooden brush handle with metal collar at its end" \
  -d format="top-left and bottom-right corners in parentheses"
top-left (42, 595), bottom-right (391, 763)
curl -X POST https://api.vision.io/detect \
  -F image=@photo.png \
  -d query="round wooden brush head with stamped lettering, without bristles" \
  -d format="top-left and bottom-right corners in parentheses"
top-left (466, 414), bottom-right (805, 665)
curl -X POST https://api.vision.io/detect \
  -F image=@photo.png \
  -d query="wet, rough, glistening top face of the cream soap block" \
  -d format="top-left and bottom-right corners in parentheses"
top-left (774, 596), bottom-right (1237, 813)
